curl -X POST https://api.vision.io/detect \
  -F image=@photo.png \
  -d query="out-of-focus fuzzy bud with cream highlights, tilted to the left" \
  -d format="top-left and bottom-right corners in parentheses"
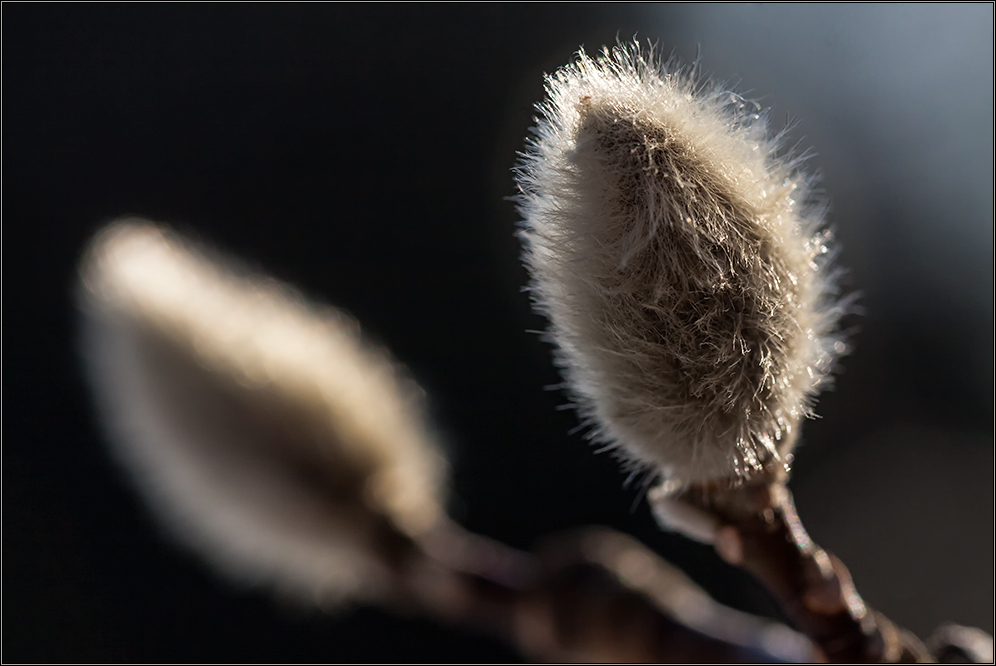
top-left (81, 220), bottom-right (446, 604)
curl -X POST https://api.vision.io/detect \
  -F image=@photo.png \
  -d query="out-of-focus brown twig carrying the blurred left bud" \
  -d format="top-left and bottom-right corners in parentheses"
top-left (394, 524), bottom-right (817, 663)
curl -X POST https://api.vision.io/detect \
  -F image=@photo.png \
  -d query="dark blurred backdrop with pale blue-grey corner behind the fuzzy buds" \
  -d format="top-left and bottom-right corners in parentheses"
top-left (3, 4), bottom-right (994, 662)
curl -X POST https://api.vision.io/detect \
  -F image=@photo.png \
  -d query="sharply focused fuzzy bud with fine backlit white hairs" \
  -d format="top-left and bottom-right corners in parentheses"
top-left (516, 45), bottom-right (844, 483)
